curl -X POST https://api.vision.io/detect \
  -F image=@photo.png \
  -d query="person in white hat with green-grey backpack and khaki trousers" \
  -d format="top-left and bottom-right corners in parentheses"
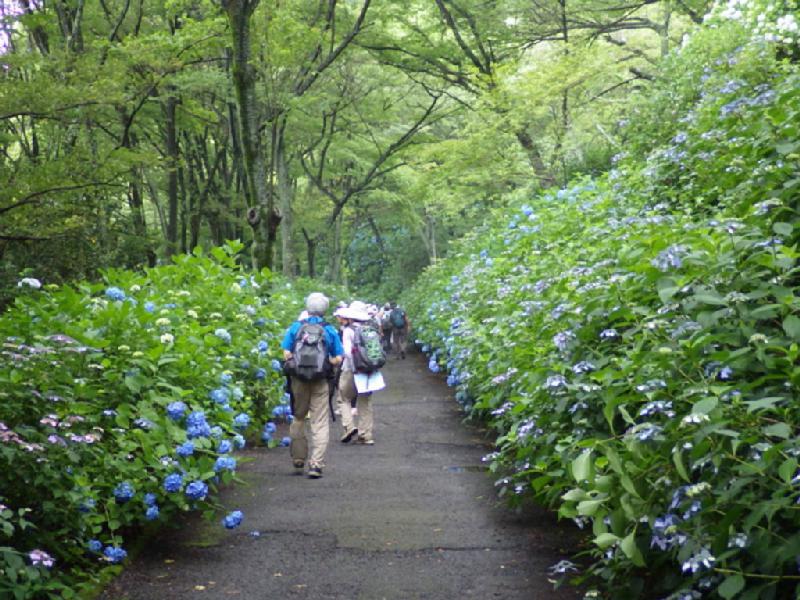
top-left (337, 301), bottom-right (386, 446)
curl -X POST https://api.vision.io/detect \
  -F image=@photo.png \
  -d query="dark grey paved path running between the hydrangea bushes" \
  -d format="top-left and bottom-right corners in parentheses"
top-left (102, 354), bottom-right (579, 600)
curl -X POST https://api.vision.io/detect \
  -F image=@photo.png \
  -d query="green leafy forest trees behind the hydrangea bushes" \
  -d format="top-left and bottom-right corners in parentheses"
top-left (0, 0), bottom-right (708, 305)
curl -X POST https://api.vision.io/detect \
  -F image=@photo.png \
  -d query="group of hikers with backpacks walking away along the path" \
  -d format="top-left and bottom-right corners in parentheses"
top-left (281, 292), bottom-right (410, 479)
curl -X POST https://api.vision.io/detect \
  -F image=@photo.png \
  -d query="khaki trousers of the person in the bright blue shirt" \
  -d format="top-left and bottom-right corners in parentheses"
top-left (289, 377), bottom-right (330, 469)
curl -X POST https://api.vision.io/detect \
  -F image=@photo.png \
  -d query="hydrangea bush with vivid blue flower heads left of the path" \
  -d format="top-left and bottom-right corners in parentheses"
top-left (0, 243), bottom-right (340, 598)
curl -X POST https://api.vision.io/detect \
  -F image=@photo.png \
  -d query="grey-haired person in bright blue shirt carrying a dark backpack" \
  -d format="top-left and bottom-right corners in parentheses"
top-left (281, 292), bottom-right (344, 479)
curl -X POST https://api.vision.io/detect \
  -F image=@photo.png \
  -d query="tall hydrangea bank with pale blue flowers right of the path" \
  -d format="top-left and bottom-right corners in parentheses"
top-left (405, 17), bottom-right (800, 599)
